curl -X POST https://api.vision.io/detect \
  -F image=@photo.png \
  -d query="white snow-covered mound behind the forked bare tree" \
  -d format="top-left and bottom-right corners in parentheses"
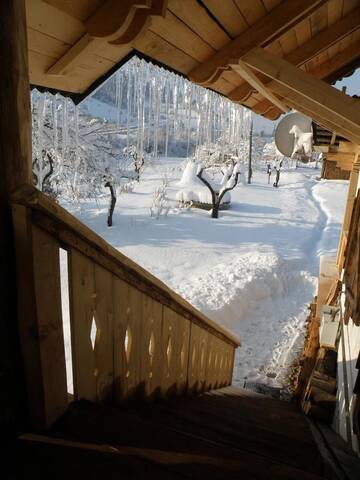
top-left (176, 161), bottom-right (231, 205)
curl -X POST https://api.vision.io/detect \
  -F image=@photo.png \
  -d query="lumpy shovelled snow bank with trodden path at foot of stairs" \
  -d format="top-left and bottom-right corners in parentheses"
top-left (179, 252), bottom-right (316, 388)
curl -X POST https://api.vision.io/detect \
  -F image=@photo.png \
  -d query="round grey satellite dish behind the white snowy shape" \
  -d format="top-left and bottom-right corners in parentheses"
top-left (275, 112), bottom-right (312, 157)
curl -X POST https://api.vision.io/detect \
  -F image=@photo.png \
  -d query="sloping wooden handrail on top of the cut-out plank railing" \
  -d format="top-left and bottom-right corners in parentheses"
top-left (11, 185), bottom-right (241, 348)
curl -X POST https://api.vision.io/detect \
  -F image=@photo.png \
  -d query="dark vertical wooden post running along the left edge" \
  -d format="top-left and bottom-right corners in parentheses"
top-left (0, 0), bottom-right (31, 436)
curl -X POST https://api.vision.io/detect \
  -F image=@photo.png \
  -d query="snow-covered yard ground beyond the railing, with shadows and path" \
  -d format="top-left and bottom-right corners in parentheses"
top-left (61, 158), bottom-right (348, 396)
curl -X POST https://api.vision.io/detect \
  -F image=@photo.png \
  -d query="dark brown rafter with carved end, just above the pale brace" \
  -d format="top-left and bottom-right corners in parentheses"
top-left (188, 0), bottom-right (327, 85)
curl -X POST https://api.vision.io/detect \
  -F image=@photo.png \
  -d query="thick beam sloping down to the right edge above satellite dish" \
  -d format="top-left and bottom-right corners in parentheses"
top-left (243, 48), bottom-right (360, 144)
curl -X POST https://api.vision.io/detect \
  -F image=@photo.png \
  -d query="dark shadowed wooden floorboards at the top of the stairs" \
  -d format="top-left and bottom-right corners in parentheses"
top-left (19, 388), bottom-right (323, 480)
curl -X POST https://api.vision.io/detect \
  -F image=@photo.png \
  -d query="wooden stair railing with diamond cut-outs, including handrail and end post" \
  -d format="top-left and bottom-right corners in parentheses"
top-left (12, 186), bottom-right (240, 427)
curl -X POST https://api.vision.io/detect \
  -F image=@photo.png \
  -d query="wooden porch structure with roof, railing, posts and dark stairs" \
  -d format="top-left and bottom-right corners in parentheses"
top-left (0, 0), bottom-right (360, 479)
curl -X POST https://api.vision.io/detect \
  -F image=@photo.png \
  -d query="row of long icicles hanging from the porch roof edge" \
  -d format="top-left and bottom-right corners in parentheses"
top-left (32, 57), bottom-right (251, 191)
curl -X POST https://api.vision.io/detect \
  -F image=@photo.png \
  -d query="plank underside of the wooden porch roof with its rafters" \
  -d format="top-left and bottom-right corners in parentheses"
top-left (26, 0), bottom-right (360, 120)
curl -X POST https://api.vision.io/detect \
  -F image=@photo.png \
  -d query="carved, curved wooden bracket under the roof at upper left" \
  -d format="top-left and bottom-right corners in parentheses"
top-left (46, 0), bottom-right (167, 75)
